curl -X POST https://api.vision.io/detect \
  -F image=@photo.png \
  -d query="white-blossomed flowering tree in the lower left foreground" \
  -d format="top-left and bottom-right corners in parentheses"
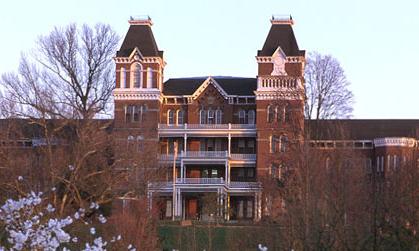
top-left (0, 192), bottom-right (136, 251)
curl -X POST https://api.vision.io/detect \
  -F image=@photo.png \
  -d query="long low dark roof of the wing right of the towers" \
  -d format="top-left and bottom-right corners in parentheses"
top-left (305, 119), bottom-right (419, 140)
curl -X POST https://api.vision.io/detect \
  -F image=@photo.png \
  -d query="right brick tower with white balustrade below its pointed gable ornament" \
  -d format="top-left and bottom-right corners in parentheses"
top-left (255, 16), bottom-right (305, 178)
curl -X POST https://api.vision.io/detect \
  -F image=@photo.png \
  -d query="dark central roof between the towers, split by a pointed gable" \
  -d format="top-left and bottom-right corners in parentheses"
top-left (163, 77), bottom-right (257, 96)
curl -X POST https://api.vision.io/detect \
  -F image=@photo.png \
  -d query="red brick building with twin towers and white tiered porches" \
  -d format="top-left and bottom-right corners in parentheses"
top-left (110, 18), bottom-right (419, 220)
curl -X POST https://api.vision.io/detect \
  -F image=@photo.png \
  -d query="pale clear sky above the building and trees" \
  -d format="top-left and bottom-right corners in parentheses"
top-left (0, 0), bottom-right (419, 119)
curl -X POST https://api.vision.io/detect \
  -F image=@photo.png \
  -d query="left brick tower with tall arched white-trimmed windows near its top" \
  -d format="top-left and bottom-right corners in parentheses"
top-left (114, 17), bottom-right (165, 143)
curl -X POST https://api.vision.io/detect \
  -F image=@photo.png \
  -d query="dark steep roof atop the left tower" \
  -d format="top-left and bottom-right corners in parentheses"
top-left (116, 25), bottom-right (163, 57)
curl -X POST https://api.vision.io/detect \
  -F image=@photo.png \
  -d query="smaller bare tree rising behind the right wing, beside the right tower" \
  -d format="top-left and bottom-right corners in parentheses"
top-left (304, 52), bottom-right (354, 120)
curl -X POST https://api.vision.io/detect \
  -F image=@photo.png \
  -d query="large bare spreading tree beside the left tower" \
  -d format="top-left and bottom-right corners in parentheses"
top-left (1, 24), bottom-right (119, 119)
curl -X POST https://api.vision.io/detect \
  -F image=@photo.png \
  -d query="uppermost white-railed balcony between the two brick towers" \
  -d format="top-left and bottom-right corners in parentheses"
top-left (158, 123), bottom-right (256, 137)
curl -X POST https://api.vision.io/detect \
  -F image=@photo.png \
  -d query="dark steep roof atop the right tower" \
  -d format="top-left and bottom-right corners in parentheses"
top-left (258, 24), bottom-right (305, 56)
